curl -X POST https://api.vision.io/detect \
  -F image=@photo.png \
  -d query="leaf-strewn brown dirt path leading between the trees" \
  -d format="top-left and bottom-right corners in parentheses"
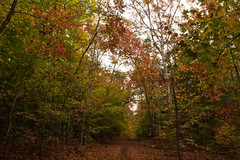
top-left (83, 139), bottom-right (171, 160)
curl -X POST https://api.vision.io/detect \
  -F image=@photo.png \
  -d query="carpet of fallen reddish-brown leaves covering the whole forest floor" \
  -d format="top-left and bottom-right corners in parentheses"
top-left (1, 139), bottom-right (229, 160)
